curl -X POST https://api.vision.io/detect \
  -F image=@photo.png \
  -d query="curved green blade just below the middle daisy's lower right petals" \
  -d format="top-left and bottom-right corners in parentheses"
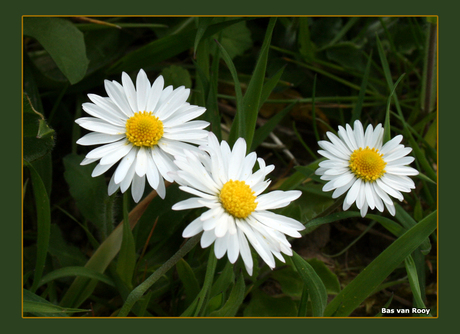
top-left (292, 252), bottom-right (327, 317)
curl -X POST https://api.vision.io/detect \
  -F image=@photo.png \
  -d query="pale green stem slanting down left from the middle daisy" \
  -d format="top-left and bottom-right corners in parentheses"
top-left (118, 234), bottom-right (201, 317)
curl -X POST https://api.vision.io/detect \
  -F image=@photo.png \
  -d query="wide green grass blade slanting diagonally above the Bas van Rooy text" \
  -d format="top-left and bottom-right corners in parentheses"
top-left (324, 211), bottom-right (437, 317)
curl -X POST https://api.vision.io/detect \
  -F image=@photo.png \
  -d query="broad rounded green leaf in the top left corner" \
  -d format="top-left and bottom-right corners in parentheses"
top-left (23, 17), bottom-right (88, 84)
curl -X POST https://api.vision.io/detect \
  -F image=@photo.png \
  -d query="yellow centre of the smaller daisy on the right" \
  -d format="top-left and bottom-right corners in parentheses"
top-left (349, 146), bottom-right (387, 182)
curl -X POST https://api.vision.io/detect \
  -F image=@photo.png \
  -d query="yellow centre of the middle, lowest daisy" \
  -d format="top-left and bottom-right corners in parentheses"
top-left (219, 180), bottom-right (257, 218)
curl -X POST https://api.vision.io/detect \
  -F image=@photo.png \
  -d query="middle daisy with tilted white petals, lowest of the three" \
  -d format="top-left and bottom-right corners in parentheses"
top-left (172, 132), bottom-right (305, 275)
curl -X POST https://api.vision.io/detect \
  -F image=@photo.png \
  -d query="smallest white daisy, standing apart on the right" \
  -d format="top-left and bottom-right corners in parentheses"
top-left (316, 121), bottom-right (418, 217)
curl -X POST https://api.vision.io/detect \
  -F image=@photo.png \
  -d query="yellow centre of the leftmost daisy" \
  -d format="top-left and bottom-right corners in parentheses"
top-left (126, 111), bottom-right (163, 147)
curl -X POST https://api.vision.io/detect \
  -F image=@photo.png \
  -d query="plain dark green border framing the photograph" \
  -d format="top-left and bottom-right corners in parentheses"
top-left (12, 0), bottom-right (452, 334)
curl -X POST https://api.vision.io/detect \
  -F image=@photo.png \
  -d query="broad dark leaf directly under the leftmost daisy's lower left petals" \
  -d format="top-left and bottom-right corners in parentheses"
top-left (62, 154), bottom-right (113, 239)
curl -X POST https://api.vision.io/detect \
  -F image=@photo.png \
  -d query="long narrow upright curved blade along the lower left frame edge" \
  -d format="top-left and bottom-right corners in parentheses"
top-left (24, 161), bottom-right (51, 292)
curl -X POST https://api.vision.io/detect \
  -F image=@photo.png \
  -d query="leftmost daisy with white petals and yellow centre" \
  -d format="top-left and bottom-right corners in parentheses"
top-left (75, 69), bottom-right (209, 202)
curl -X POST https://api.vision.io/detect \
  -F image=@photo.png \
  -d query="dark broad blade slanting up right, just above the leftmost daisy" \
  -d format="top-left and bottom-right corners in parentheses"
top-left (109, 18), bottom-right (249, 74)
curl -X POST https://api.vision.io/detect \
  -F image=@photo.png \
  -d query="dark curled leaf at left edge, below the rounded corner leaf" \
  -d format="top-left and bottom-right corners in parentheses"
top-left (22, 94), bottom-right (54, 162)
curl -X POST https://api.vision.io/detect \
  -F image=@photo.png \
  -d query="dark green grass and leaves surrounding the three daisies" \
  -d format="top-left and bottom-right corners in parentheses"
top-left (22, 16), bottom-right (438, 317)
